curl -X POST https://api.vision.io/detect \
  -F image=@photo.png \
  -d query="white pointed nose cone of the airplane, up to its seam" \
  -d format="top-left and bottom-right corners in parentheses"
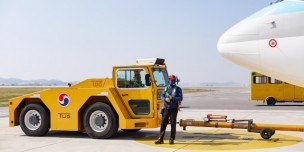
top-left (217, 20), bottom-right (259, 69)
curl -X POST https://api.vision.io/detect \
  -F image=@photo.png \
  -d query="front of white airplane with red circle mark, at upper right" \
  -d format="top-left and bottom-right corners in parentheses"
top-left (217, 0), bottom-right (304, 87)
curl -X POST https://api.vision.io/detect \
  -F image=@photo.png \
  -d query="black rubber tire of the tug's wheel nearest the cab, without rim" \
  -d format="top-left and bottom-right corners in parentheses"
top-left (83, 102), bottom-right (118, 139)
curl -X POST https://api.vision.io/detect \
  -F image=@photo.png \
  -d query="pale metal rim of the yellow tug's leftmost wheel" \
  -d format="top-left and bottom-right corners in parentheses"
top-left (24, 110), bottom-right (42, 130)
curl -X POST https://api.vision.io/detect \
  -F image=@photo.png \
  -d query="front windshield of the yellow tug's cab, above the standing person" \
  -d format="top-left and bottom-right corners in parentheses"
top-left (152, 68), bottom-right (168, 87)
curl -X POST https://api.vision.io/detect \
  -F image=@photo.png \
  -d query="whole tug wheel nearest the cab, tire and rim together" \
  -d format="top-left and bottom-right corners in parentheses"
top-left (83, 102), bottom-right (118, 139)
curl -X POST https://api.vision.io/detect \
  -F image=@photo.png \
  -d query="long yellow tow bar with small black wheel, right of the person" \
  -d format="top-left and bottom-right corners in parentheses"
top-left (179, 114), bottom-right (304, 139)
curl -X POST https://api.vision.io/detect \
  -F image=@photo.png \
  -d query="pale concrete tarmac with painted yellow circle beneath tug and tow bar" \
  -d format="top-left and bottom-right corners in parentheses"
top-left (0, 88), bottom-right (304, 152)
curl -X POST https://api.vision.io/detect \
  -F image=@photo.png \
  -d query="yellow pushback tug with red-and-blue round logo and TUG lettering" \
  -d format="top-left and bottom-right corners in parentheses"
top-left (9, 58), bottom-right (168, 138)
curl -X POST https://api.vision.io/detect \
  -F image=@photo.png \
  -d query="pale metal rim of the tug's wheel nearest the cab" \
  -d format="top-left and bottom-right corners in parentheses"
top-left (89, 110), bottom-right (109, 132)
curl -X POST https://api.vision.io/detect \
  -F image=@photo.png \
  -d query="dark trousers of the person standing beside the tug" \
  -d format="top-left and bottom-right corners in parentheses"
top-left (159, 109), bottom-right (178, 140)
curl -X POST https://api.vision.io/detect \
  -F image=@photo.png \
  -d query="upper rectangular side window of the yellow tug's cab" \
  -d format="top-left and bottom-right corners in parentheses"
top-left (116, 69), bottom-right (146, 88)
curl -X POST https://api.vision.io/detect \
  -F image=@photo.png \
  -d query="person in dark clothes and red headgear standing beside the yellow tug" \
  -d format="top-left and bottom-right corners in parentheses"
top-left (155, 75), bottom-right (183, 144)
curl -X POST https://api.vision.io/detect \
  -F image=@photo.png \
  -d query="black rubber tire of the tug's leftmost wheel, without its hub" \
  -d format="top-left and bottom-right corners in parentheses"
top-left (19, 104), bottom-right (50, 136)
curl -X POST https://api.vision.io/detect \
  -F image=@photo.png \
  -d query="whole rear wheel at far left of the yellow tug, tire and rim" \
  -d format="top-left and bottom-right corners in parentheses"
top-left (19, 104), bottom-right (50, 136)
